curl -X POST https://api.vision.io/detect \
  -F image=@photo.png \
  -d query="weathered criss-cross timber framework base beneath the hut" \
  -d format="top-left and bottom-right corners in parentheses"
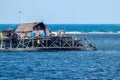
top-left (0, 36), bottom-right (95, 51)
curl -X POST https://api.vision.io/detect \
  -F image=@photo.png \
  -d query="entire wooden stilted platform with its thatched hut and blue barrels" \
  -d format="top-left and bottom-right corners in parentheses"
top-left (0, 22), bottom-right (96, 51)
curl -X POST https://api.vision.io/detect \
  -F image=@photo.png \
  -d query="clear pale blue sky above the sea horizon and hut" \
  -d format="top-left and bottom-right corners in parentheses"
top-left (0, 0), bottom-right (120, 24)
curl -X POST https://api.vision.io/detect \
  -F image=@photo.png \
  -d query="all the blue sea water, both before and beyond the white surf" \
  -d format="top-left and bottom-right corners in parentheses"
top-left (0, 24), bottom-right (120, 80)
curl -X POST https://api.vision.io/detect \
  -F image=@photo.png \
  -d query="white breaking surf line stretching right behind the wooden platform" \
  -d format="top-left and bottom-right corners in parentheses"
top-left (52, 31), bottom-right (120, 34)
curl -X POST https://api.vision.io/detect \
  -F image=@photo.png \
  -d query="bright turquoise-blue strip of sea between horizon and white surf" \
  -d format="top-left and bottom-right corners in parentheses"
top-left (0, 24), bottom-right (120, 33)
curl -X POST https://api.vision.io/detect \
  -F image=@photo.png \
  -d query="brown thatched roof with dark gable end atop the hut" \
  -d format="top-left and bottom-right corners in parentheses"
top-left (15, 22), bottom-right (49, 33)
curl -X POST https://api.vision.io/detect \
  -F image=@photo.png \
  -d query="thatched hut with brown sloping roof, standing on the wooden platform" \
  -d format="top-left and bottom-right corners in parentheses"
top-left (15, 22), bottom-right (51, 36)
